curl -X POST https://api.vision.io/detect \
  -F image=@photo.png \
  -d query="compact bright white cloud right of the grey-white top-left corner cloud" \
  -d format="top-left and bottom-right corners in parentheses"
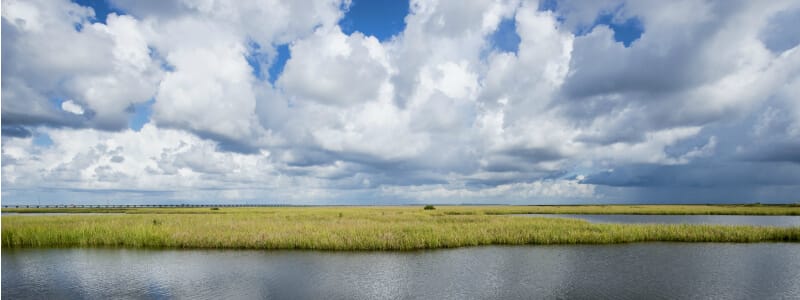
top-left (153, 43), bottom-right (257, 140)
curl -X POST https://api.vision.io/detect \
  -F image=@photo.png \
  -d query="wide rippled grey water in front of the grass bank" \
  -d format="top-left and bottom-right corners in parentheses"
top-left (2, 243), bottom-right (800, 299)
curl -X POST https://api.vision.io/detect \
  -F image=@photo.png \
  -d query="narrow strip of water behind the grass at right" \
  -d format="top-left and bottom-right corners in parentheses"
top-left (514, 214), bottom-right (800, 227)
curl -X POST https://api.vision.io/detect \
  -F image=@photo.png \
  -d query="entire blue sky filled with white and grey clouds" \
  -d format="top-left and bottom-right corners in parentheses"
top-left (1, 0), bottom-right (800, 204)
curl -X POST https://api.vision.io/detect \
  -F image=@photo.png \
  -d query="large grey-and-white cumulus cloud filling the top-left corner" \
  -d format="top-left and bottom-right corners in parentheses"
top-left (2, 1), bottom-right (160, 130)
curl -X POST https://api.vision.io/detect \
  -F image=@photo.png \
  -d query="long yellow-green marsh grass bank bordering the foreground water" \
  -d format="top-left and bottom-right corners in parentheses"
top-left (2, 206), bottom-right (800, 250)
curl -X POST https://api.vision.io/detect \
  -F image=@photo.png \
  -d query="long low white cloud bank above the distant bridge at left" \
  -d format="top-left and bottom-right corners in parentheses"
top-left (3, 124), bottom-right (274, 191)
